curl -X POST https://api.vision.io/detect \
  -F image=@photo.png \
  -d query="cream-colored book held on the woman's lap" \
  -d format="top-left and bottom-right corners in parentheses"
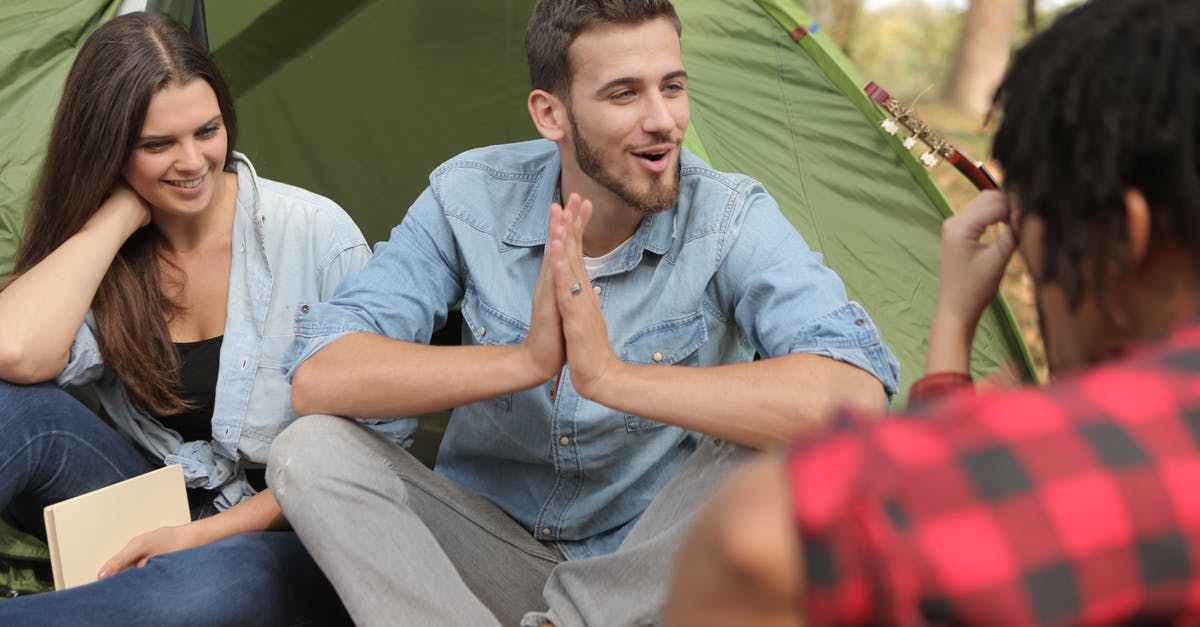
top-left (43, 464), bottom-right (192, 590)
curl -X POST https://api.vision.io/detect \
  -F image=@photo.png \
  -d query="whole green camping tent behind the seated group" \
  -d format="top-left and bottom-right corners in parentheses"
top-left (0, 0), bottom-right (1032, 407)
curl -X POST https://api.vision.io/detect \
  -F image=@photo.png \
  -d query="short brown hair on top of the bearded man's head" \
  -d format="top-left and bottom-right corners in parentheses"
top-left (526, 0), bottom-right (682, 98)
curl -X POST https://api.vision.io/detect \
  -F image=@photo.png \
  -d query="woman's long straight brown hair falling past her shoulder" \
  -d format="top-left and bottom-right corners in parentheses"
top-left (13, 13), bottom-right (238, 416)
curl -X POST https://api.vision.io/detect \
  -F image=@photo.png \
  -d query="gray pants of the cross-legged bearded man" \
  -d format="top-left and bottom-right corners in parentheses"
top-left (268, 416), bottom-right (750, 627)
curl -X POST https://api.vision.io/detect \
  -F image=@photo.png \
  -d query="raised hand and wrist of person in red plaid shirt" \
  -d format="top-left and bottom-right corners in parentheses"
top-left (925, 191), bottom-right (1016, 372)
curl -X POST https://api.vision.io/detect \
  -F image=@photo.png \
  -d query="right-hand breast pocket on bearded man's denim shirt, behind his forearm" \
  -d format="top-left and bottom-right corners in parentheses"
top-left (619, 311), bottom-right (708, 432)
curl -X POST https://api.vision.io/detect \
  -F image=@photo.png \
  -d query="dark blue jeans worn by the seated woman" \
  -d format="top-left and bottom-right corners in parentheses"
top-left (0, 382), bottom-right (348, 626)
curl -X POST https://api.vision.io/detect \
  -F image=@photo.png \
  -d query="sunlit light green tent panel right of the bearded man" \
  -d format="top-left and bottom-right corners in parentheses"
top-left (677, 0), bottom-right (1033, 389)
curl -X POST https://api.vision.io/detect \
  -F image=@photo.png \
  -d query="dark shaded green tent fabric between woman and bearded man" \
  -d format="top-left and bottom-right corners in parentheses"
top-left (206, 0), bottom-right (535, 241)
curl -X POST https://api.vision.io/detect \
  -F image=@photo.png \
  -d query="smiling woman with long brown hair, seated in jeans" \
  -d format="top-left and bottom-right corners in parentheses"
top-left (0, 13), bottom-right (409, 625)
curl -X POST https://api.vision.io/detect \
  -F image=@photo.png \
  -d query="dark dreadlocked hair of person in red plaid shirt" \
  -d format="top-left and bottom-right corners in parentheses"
top-left (992, 0), bottom-right (1200, 307)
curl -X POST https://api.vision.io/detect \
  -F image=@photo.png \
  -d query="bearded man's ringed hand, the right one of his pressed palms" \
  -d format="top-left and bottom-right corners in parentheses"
top-left (550, 193), bottom-right (620, 400)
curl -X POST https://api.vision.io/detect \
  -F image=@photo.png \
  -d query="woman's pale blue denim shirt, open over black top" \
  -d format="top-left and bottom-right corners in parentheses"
top-left (55, 153), bottom-right (415, 509)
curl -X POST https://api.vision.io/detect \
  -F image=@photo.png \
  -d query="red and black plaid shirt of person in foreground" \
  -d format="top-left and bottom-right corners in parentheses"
top-left (787, 324), bottom-right (1200, 626)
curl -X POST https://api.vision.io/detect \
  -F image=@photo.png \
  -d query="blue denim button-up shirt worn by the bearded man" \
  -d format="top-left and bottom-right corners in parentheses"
top-left (290, 141), bottom-right (899, 559)
